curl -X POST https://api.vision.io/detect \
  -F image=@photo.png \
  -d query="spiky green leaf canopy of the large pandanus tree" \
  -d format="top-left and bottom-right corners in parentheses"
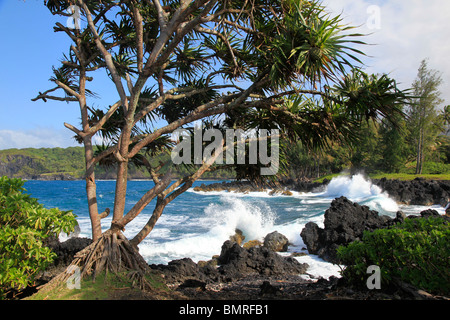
top-left (40, 0), bottom-right (414, 178)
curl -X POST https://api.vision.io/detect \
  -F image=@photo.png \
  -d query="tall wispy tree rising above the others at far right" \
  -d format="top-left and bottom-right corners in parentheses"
top-left (407, 60), bottom-right (443, 174)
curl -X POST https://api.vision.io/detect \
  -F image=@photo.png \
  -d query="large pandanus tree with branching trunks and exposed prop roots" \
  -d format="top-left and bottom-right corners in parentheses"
top-left (33, 0), bottom-right (405, 284)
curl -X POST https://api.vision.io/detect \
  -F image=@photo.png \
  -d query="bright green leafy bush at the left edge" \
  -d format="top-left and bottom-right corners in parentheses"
top-left (0, 177), bottom-right (77, 299)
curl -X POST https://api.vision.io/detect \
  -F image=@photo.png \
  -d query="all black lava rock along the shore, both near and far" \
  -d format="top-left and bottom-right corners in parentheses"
top-left (25, 179), bottom-right (450, 300)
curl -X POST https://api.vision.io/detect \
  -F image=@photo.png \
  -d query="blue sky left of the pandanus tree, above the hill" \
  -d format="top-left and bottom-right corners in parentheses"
top-left (0, 0), bottom-right (78, 149)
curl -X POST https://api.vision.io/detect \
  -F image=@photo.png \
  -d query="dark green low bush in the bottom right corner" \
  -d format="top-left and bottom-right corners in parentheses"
top-left (338, 217), bottom-right (450, 295)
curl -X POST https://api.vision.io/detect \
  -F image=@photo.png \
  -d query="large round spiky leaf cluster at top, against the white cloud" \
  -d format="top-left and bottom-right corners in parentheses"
top-left (254, 1), bottom-right (364, 88)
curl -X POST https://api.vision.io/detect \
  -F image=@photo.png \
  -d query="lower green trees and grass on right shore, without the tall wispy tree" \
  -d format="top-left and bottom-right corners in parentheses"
top-left (287, 117), bottom-right (450, 180)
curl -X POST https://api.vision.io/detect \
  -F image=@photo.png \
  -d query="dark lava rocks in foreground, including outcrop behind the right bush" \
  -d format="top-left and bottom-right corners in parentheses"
top-left (151, 197), bottom-right (450, 300)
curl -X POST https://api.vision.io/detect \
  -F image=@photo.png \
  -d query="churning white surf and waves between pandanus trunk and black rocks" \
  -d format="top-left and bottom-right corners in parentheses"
top-left (73, 175), bottom-right (436, 279)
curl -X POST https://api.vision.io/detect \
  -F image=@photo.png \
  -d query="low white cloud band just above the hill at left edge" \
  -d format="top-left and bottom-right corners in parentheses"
top-left (0, 128), bottom-right (77, 150)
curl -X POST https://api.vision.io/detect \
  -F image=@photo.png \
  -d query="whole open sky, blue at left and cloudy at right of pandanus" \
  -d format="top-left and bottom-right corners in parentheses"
top-left (0, 0), bottom-right (450, 150)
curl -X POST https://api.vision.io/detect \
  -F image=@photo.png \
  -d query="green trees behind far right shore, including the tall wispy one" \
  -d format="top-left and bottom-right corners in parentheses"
top-left (287, 60), bottom-right (450, 178)
